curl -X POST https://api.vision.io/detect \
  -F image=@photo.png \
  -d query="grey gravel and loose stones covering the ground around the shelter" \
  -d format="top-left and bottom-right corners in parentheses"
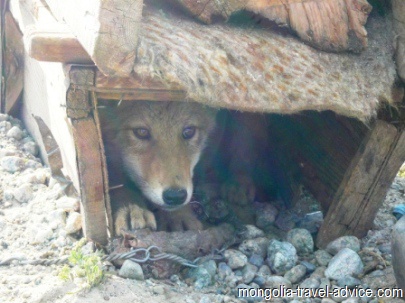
top-left (0, 114), bottom-right (405, 303)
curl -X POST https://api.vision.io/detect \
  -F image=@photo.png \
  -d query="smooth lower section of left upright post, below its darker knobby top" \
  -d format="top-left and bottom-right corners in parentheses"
top-left (72, 117), bottom-right (108, 245)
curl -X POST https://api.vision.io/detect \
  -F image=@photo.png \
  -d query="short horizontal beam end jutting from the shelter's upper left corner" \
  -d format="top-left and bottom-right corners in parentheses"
top-left (24, 24), bottom-right (93, 64)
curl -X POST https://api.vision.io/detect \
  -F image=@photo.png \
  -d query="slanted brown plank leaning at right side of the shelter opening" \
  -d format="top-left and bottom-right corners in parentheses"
top-left (317, 120), bottom-right (405, 247)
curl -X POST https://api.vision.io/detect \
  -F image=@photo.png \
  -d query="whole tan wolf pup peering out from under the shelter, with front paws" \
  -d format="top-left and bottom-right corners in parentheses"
top-left (99, 101), bottom-right (216, 235)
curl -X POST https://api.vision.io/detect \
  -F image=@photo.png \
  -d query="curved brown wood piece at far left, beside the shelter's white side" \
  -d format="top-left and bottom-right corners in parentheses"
top-left (3, 12), bottom-right (24, 113)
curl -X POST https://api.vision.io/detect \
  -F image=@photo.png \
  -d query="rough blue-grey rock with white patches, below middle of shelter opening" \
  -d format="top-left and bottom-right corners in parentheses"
top-left (267, 239), bottom-right (298, 275)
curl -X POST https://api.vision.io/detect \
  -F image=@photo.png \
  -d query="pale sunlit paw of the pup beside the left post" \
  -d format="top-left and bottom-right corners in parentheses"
top-left (114, 204), bottom-right (156, 236)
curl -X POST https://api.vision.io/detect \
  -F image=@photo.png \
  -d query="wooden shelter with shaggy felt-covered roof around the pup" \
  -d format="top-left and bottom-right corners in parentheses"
top-left (2, 0), bottom-right (405, 252)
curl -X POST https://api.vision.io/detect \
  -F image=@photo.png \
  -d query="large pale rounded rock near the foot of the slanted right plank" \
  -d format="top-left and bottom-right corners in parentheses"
top-left (325, 248), bottom-right (363, 280)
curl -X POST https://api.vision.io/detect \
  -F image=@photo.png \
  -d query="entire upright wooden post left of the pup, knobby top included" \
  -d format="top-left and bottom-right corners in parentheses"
top-left (66, 68), bottom-right (108, 245)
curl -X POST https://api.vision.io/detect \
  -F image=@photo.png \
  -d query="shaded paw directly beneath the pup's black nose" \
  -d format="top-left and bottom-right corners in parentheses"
top-left (156, 205), bottom-right (203, 231)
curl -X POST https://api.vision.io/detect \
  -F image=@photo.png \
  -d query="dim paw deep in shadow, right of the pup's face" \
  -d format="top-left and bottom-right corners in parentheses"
top-left (221, 176), bottom-right (256, 205)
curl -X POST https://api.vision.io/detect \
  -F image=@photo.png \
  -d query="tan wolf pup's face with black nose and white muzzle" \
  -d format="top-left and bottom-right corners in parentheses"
top-left (116, 101), bottom-right (216, 210)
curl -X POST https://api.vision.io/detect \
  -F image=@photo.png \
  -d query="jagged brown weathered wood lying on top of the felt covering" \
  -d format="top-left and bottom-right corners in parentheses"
top-left (170, 0), bottom-right (370, 52)
